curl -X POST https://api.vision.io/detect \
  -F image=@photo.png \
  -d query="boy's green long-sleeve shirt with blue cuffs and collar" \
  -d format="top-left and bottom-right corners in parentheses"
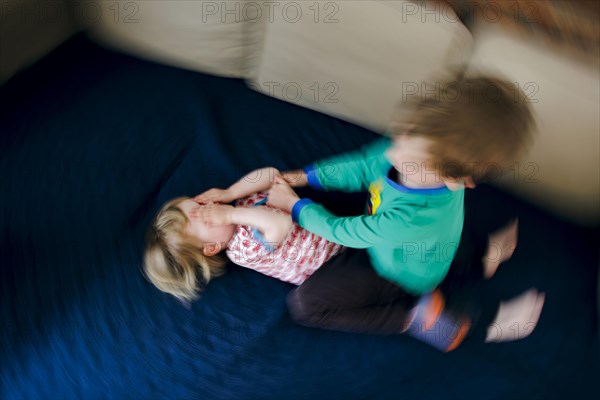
top-left (292, 138), bottom-right (464, 295)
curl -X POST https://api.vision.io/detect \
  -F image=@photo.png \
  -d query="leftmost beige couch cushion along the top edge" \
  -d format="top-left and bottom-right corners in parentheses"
top-left (86, 0), bottom-right (266, 77)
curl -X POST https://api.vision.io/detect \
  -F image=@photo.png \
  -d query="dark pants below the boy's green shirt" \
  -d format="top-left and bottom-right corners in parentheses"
top-left (287, 219), bottom-right (497, 334)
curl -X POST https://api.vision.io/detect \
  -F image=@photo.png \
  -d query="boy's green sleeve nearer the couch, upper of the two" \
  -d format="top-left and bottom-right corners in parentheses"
top-left (311, 138), bottom-right (391, 192)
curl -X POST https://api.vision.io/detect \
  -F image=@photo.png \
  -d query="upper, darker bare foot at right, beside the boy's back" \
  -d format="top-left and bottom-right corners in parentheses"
top-left (482, 219), bottom-right (519, 279)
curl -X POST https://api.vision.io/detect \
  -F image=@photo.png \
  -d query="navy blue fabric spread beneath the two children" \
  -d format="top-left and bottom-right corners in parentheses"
top-left (0, 35), bottom-right (598, 399)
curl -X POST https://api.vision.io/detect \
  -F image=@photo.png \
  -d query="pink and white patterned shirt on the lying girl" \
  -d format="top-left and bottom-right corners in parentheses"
top-left (226, 193), bottom-right (344, 285)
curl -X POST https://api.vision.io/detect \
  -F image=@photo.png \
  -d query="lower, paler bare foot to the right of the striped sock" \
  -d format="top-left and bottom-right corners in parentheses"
top-left (485, 289), bottom-right (545, 343)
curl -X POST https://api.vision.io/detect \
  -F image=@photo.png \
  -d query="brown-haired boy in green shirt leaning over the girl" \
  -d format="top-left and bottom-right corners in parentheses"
top-left (269, 77), bottom-right (543, 348)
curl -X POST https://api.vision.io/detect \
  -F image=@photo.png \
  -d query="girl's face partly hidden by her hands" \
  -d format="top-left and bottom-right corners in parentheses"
top-left (179, 199), bottom-right (236, 247)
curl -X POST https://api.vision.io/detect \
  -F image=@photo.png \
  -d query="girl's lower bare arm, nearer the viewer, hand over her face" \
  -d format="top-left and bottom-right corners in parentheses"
top-left (200, 204), bottom-right (292, 243)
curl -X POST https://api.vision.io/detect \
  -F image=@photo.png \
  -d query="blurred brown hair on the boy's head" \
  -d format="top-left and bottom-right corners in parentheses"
top-left (391, 77), bottom-right (535, 187)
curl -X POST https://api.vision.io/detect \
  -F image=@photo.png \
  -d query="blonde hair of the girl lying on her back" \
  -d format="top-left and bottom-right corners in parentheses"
top-left (144, 197), bottom-right (226, 304)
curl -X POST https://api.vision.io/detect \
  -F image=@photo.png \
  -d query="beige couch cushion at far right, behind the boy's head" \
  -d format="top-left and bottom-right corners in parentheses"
top-left (470, 24), bottom-right (600, 225)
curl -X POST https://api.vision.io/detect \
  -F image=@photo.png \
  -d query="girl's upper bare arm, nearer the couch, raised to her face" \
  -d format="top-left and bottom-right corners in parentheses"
top-left (194, 167), bottom-right (280, 204)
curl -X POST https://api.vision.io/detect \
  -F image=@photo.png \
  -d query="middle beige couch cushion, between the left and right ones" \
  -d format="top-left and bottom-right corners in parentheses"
top-left (248, 1), bottom-right (472, 132)
